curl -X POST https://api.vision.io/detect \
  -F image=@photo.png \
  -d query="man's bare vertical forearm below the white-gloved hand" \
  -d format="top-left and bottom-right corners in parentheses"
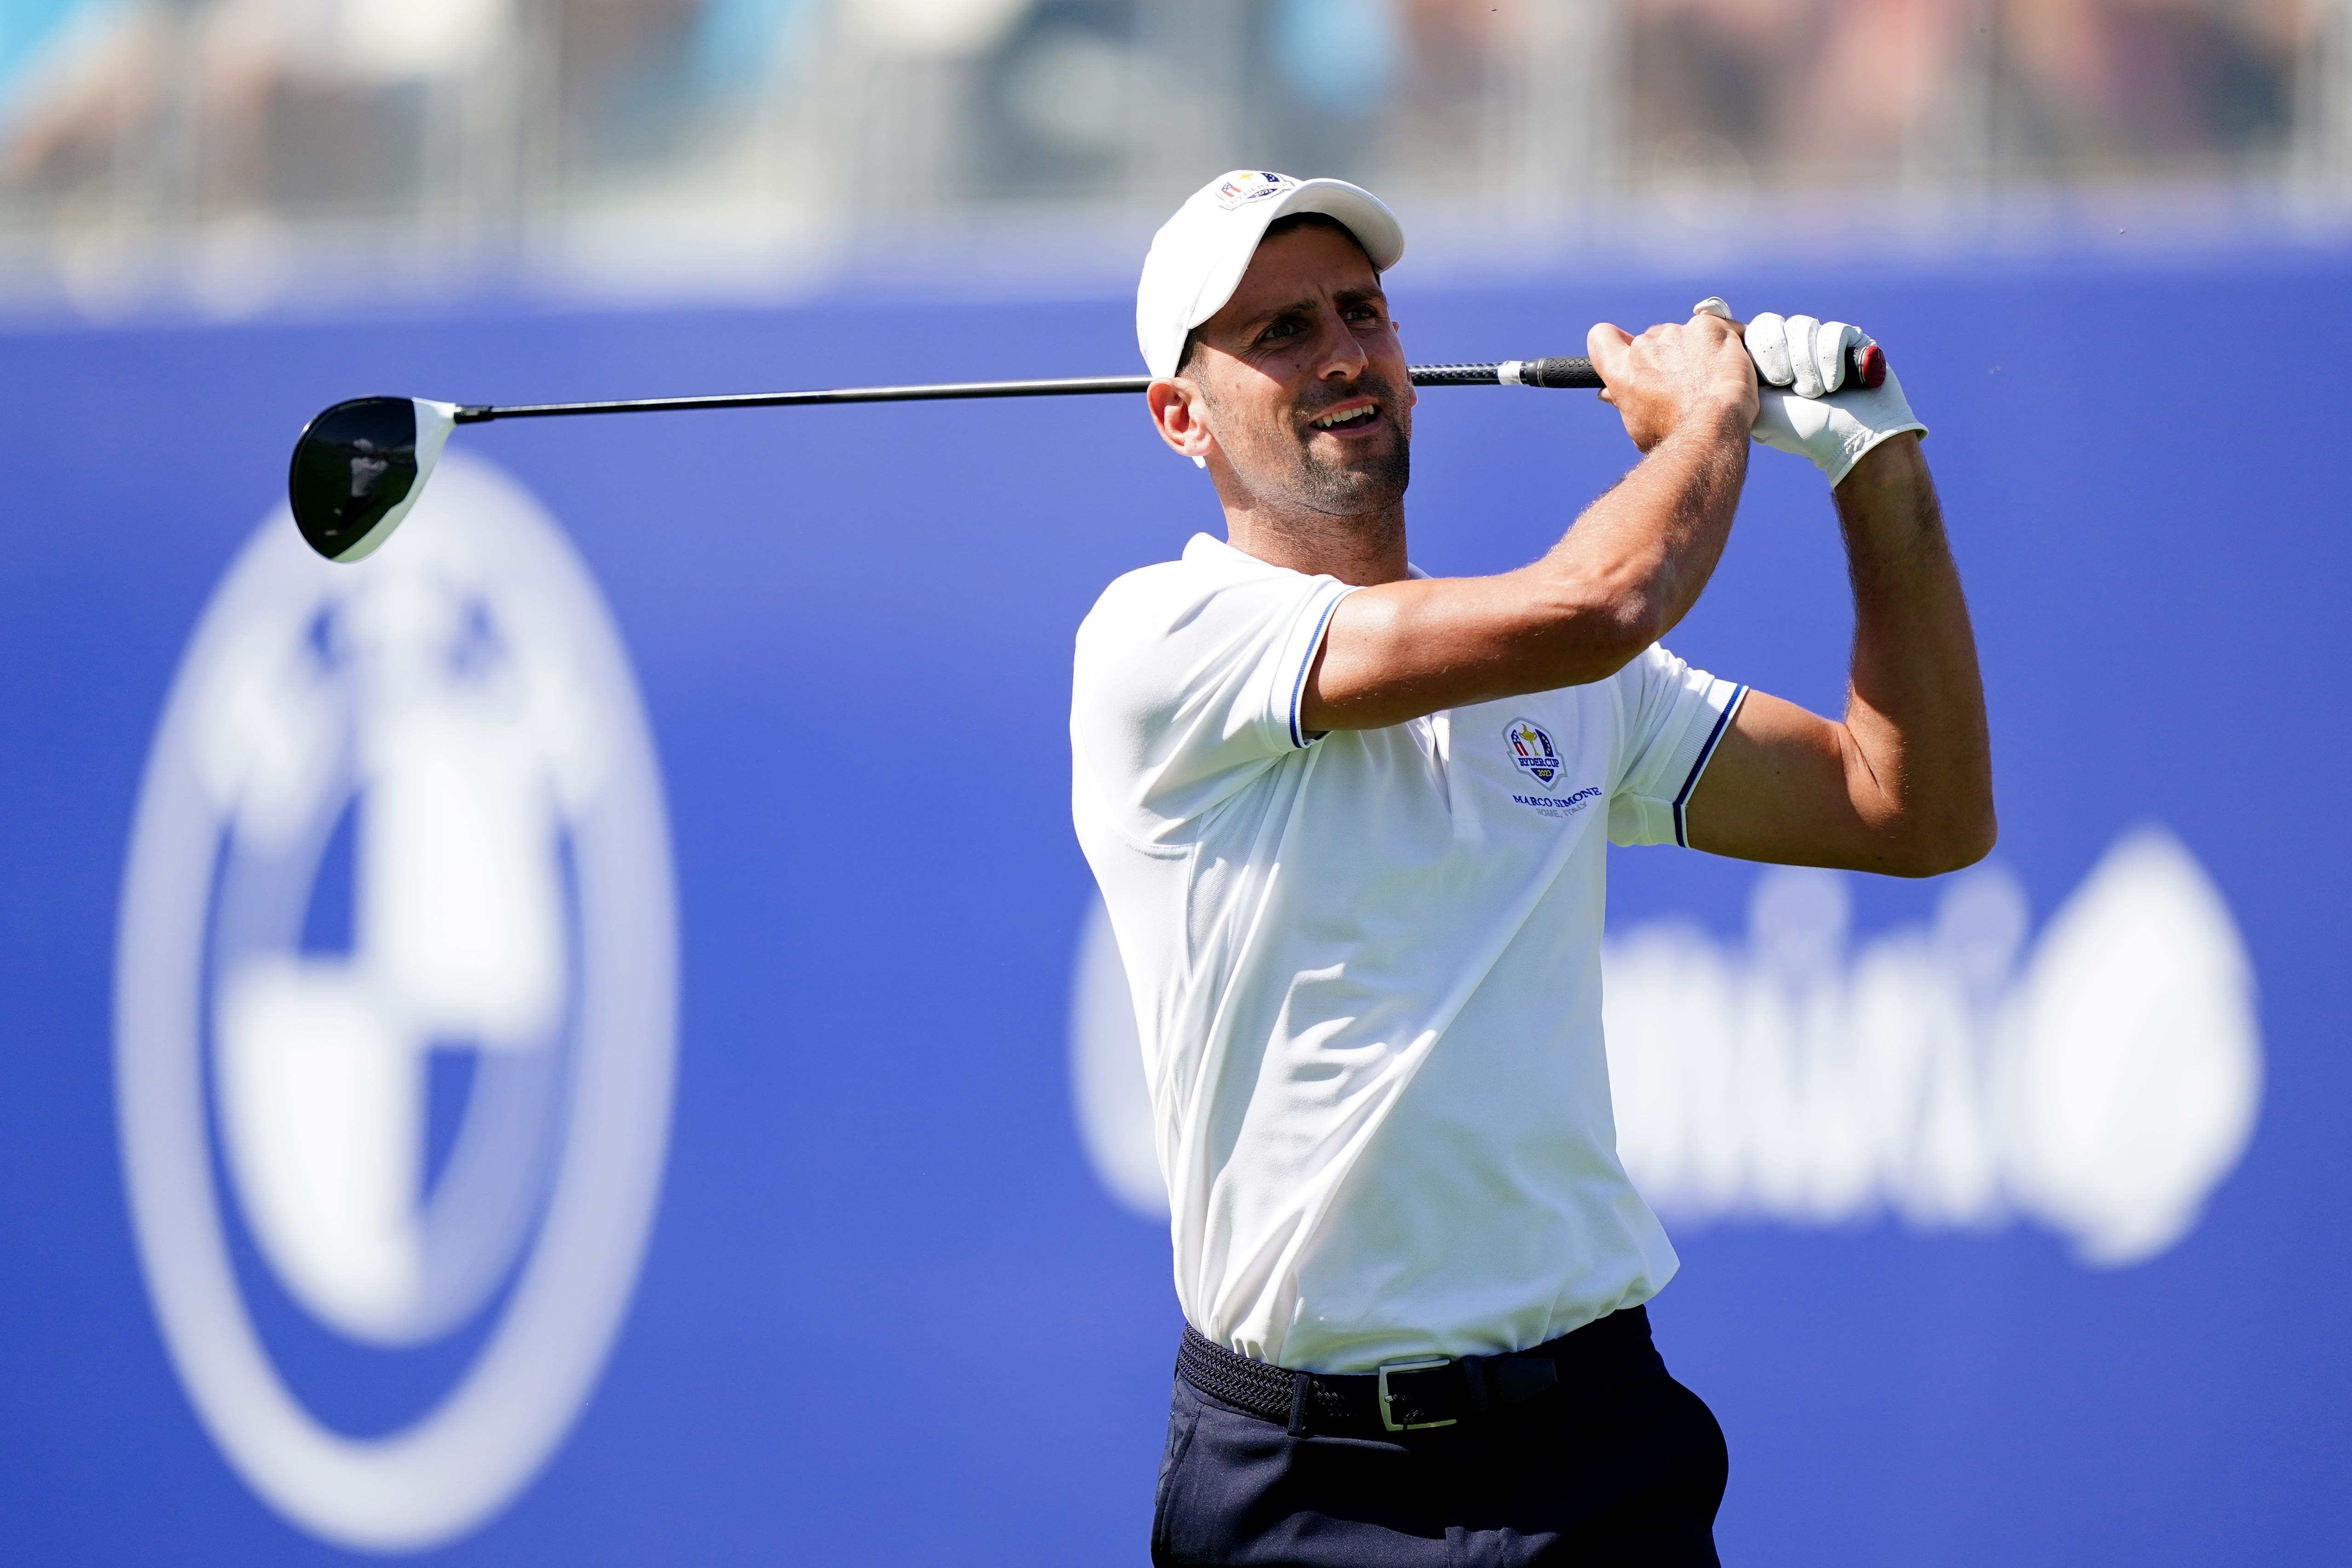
top-left (1832, 435), bottom-right (1995, 870)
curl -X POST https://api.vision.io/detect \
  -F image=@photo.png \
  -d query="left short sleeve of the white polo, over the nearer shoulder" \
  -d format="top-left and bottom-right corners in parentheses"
top-left (1070, 538), bottom-right (1352, 837)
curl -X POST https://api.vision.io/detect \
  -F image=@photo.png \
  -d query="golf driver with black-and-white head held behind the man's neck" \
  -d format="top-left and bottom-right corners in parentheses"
top-left (287, 346), bottom-right (1886, 562)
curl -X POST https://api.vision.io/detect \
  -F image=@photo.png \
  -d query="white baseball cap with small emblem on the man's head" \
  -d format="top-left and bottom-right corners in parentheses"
top-left (1136, 169), bottom-right (1404, 376)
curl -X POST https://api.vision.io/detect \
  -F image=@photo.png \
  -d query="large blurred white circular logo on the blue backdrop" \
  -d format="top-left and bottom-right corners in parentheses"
top-left (115, 456), bottom-right (677, 1551)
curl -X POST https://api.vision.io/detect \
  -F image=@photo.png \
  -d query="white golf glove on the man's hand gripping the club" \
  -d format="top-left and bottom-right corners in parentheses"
top-left (1691, 299), bottom-right (1926, 484)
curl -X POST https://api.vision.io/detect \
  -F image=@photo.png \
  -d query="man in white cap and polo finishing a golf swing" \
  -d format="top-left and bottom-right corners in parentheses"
top-left (1070, 172), bottom-right (1995, 1568)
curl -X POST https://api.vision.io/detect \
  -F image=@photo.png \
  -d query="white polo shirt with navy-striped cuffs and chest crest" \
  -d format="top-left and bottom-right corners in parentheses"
top-left (1070, 534), bottom-right (1745, 1373)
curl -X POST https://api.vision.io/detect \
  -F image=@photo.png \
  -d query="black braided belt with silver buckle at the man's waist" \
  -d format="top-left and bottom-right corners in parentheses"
top-left (1176, 1307), bottom-right (1665, 1436)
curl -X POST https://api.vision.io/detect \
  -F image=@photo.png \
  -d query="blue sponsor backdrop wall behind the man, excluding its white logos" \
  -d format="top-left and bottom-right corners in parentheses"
top-left (0, 256), bottom-right (2352, 1563)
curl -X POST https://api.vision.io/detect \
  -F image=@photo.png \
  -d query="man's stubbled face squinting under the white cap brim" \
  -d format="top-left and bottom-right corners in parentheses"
top-left (1183, 223), bottom-right (1413, 517)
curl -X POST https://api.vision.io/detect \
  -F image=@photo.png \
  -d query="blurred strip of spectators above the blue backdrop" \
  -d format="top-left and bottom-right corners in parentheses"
top-left (0, 0), bottom-right (2323, 285)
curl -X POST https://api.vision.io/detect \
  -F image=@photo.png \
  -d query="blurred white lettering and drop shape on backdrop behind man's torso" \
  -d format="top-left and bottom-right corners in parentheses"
top-left (1070, 828), bottom-right (2263, 1267)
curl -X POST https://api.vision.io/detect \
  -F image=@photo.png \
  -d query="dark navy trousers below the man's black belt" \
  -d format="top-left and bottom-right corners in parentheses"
top-left (1153, 1340), bottom-right (1729, 1568)
